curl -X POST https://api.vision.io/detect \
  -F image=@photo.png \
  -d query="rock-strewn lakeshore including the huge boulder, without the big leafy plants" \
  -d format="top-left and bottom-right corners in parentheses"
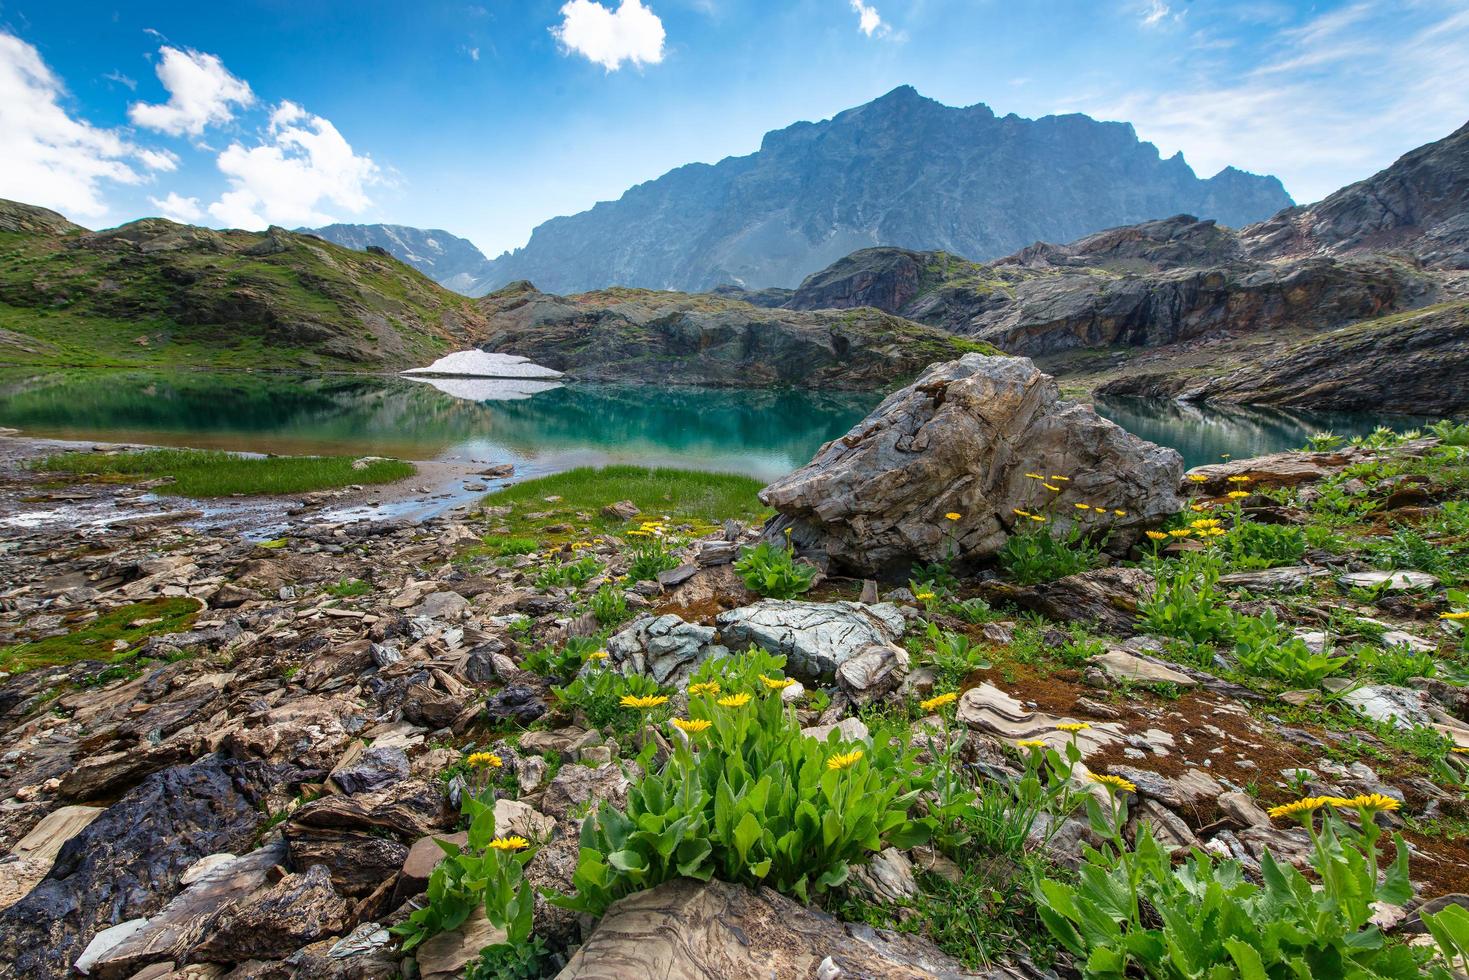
top-left (0, 356), bottom-right (1469, 980)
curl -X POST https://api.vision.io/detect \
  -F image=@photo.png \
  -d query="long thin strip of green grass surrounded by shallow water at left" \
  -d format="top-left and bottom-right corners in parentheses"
top-left (35, 450), bottom-right (416, 497)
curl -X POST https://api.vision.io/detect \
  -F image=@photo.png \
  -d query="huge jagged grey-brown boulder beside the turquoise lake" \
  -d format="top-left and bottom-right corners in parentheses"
top-left (759, 354), bottom-right (1183, 576)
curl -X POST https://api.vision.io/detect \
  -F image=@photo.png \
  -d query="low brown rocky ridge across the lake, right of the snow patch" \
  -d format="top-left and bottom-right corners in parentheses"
top-left (480, 282), bottom-right (981, 389)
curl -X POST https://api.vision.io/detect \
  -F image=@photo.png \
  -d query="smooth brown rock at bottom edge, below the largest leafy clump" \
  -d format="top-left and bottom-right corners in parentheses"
top-left (558, 879), bottom-right (1022, 980)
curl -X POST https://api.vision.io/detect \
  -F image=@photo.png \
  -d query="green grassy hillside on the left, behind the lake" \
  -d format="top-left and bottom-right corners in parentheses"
top-left (0, 201), bottom-right (485, 370)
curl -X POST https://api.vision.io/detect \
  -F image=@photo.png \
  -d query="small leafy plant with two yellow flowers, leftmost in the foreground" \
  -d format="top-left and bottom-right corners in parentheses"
top-left (391, 795), bottom-right (535, 952)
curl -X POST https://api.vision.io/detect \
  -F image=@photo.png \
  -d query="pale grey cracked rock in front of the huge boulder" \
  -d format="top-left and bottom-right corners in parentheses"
top-left (715, 599), bottom-right (905, 683)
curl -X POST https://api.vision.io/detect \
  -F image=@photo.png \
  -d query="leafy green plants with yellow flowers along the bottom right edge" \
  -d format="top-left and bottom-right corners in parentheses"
top-left (1034, 777), bottom-right (1447, 980)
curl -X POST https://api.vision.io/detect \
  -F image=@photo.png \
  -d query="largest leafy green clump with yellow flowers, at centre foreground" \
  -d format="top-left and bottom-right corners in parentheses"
top-left (552, 669), bottom-right (930, 915)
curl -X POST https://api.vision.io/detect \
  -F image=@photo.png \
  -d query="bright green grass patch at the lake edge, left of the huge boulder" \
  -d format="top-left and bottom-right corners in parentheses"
top-left (483, 466), bottom-right (770, 547)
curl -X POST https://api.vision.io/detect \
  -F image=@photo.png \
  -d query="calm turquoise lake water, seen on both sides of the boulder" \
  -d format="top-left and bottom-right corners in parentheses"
top-left (0, 369), bottom-right (1418, 479)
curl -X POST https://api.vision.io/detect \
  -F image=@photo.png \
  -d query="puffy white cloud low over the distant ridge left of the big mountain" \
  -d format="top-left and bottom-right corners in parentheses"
top-left (209, 101), bottom-right (382, 229)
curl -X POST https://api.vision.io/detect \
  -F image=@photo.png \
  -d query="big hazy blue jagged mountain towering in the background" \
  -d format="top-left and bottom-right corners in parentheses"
top-left (482, 87), bottom-right (1291, 292)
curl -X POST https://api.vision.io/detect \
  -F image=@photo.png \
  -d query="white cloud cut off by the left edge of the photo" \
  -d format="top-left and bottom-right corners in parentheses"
top-left (0, 32), bottom-right (142, 217)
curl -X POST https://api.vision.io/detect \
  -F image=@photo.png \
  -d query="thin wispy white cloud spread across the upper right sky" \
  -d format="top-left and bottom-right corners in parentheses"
top-left (1071, 0), bottom-right (1469, 203)
